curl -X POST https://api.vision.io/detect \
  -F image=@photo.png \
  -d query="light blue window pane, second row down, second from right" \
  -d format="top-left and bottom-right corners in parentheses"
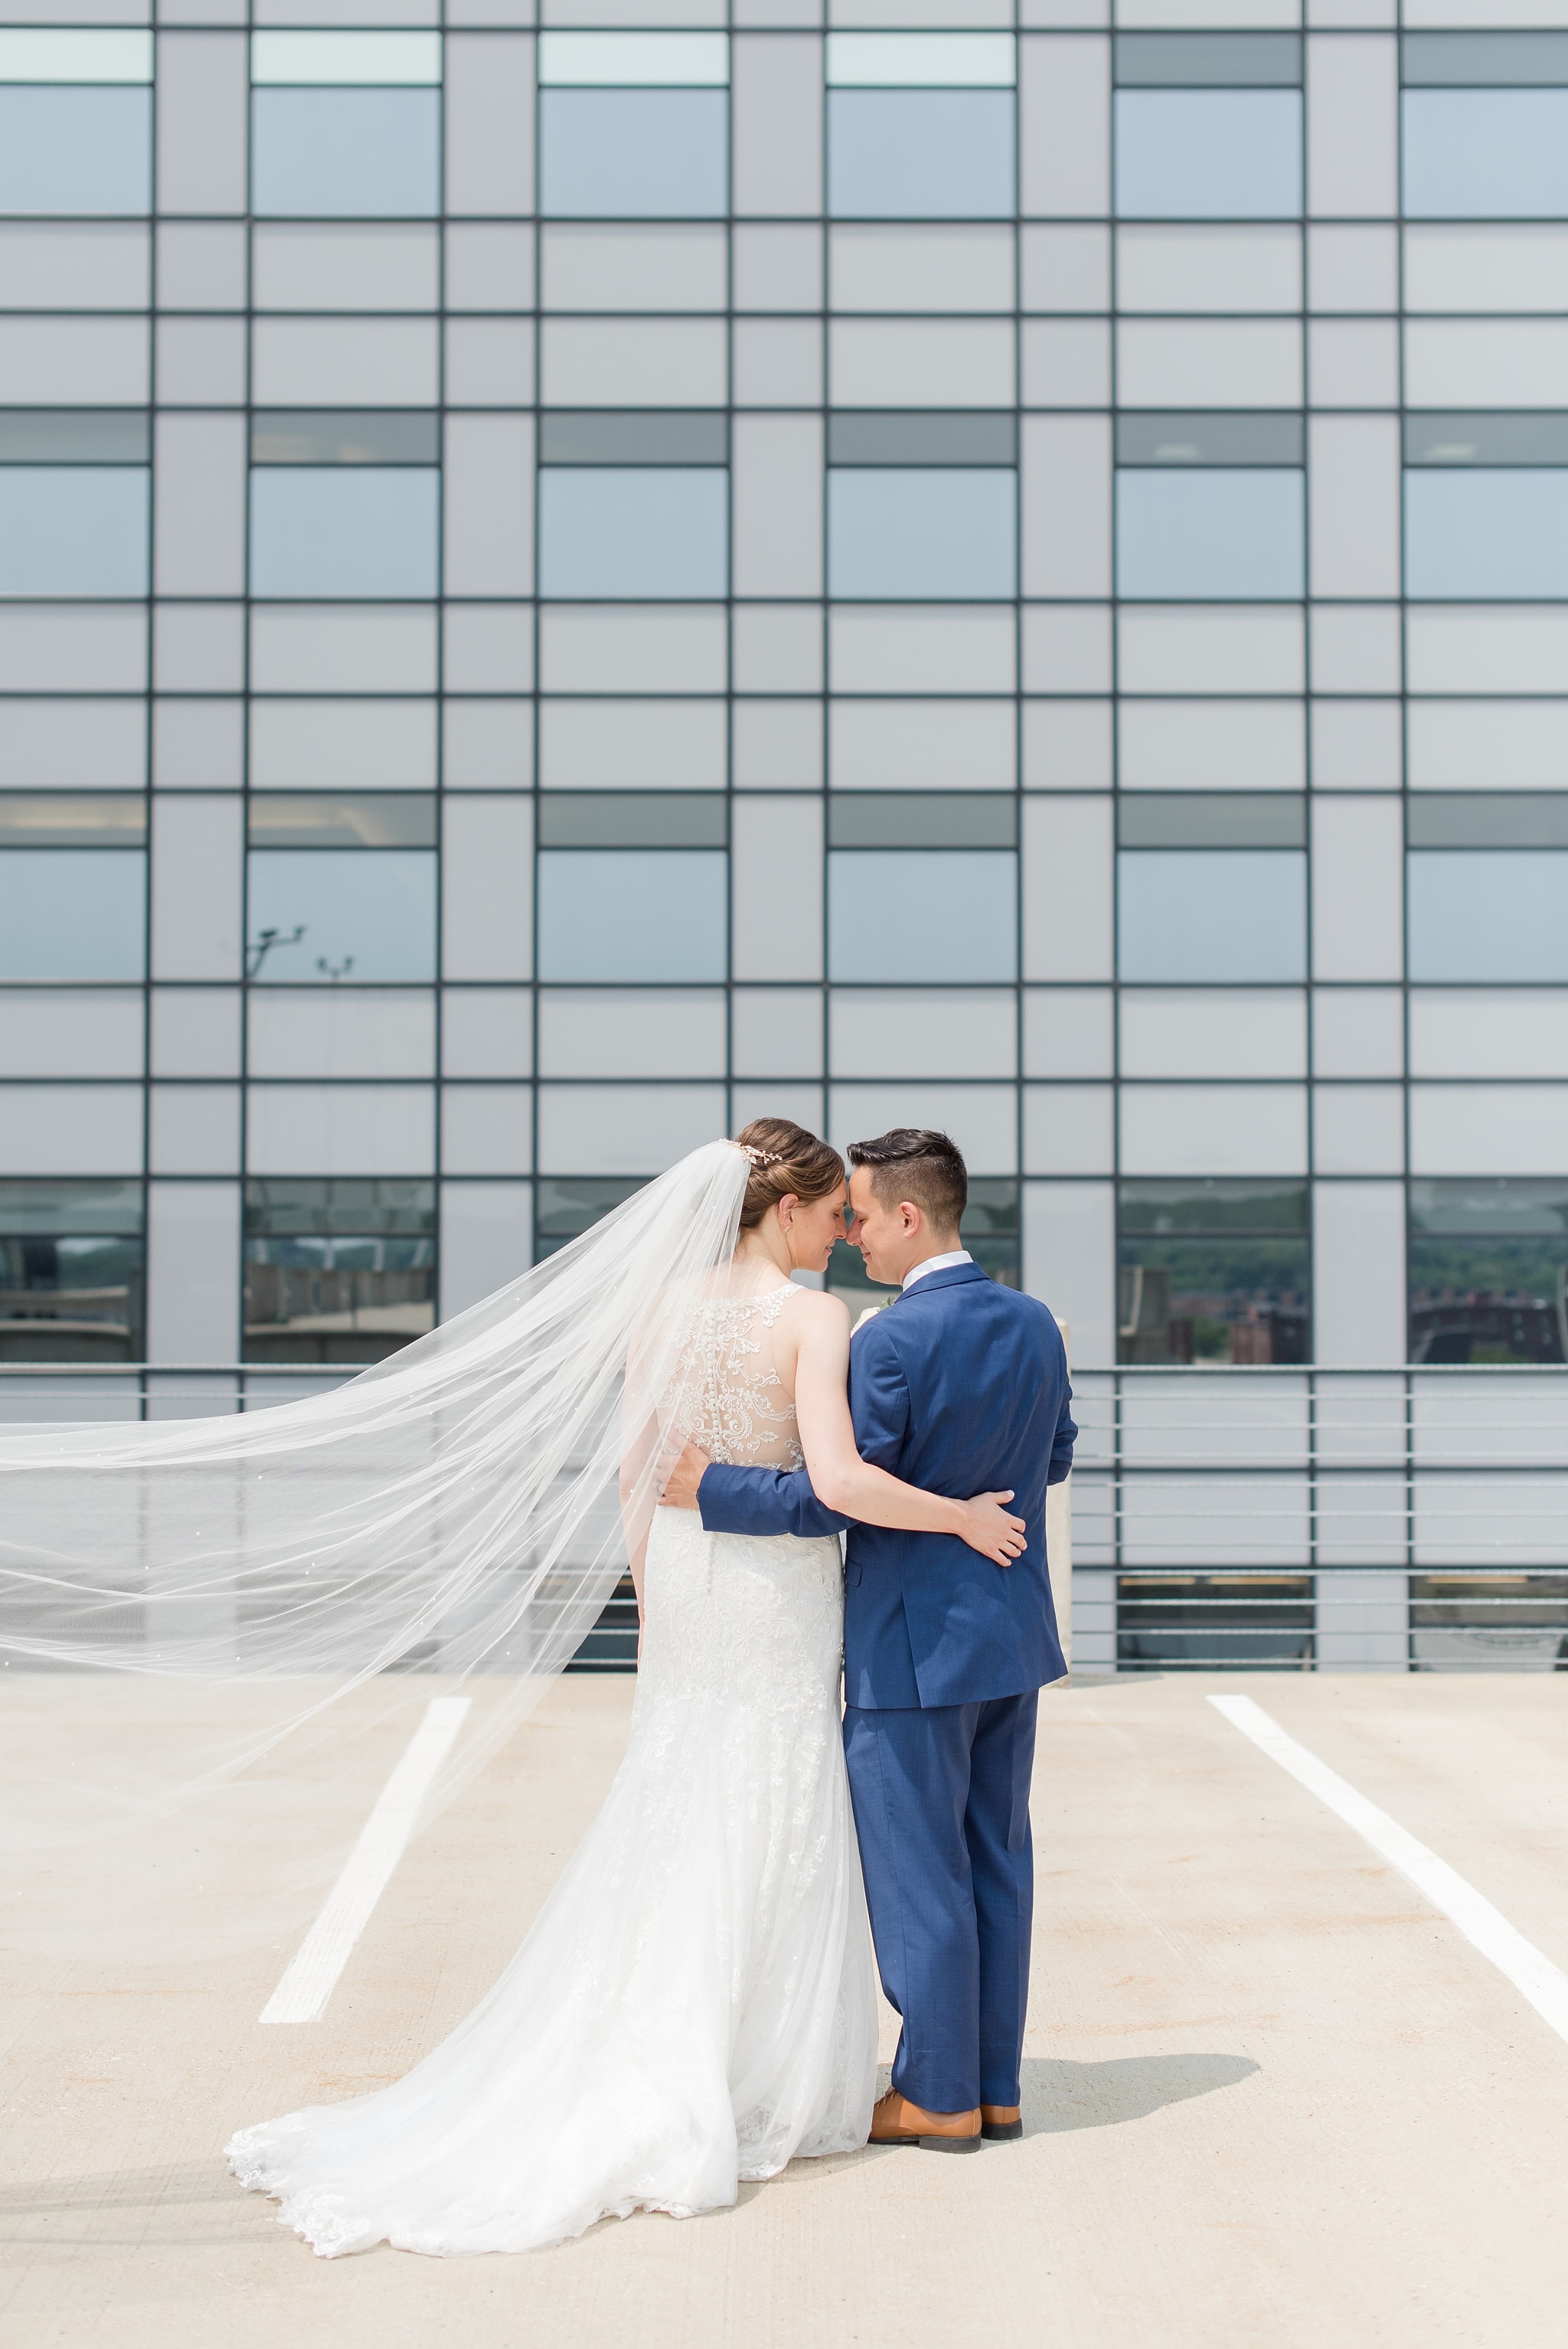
top-left (1115, 465), bottom-right (1305, 601)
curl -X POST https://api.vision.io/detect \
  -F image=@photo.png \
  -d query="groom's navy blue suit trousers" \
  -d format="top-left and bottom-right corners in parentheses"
top-left (845, 1689), bottom-right (1040, 2112)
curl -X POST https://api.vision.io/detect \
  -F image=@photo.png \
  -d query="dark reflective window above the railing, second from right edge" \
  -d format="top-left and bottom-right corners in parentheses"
top-left (1117, 1179), bottom-right (1312, 1362)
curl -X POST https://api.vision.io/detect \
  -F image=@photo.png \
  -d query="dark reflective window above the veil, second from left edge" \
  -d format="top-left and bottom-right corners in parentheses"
top-left (244, 1181), bottom-right (436, 1362)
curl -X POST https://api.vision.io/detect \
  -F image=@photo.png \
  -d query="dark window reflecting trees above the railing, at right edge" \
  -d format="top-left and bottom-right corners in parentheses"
top-left (1409, 1179), bottom-right (1568, 1362)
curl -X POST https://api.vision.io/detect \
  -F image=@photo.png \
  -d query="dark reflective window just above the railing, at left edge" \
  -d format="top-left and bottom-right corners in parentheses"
top-left (0, 1181), bottom-right (143, 1362)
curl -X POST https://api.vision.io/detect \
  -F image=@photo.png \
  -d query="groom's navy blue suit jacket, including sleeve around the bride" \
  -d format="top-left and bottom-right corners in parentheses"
top-left (697, 1264), bottom-right (1077, 1710)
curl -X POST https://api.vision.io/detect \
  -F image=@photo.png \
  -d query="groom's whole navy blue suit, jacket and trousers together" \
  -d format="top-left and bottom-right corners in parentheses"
top-left (697, 1264), bottom-right (1077, 2112)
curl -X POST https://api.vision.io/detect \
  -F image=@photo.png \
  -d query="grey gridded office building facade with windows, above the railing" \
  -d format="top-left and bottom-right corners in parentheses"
top-left (0, 0), bottom-right (1568, 1409)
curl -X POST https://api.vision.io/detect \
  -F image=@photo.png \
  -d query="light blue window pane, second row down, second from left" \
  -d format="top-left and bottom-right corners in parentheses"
top-left (251, 465), bottom-right (441, 596)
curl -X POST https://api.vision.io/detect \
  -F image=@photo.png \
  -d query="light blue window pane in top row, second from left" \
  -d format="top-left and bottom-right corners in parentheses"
top-left (251, 90), bottom-right (441, 221)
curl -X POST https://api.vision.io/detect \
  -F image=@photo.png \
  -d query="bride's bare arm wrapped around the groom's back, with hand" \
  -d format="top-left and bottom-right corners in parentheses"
top-left (795, 1289), bottom-right (1024, 1567)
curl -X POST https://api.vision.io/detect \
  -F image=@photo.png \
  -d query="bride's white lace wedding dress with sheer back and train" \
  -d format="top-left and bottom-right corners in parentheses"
top-left (227, 1285), bottom-right (876, 2257)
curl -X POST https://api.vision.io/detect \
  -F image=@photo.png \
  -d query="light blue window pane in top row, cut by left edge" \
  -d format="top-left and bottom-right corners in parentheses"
top-left (0, 87), bottom-right (152, 214)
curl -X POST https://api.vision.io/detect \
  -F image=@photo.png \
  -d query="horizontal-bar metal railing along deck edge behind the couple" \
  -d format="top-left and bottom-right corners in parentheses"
top-left (0, 1362), bottom-right (1568, 1672)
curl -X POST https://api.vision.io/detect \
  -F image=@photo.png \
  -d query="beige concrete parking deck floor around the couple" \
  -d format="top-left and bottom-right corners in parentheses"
top-left (0, 1674), bottom-right (1568, 2349)
